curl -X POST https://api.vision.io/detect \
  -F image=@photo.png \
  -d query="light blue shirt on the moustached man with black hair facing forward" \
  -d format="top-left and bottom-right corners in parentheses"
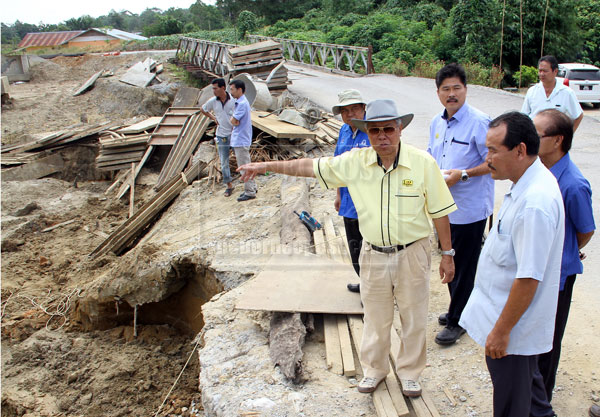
top-left (427, 102), bottom-right (494, 224)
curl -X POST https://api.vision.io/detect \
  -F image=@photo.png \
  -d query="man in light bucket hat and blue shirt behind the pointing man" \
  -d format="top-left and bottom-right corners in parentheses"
top-left (332, 90), bottom-right (371, 292)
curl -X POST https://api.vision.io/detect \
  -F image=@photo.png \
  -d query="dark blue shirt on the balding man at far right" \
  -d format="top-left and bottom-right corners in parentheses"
top-left (550, 153), bottom-right (596, 291)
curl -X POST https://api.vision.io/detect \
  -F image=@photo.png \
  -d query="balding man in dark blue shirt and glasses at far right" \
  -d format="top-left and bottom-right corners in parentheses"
top-left (533, 109), bottom-right (596, 401)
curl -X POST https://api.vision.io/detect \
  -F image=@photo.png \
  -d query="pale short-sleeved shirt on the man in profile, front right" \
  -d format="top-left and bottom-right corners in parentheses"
top-left (459, 159), bottom-right (565, 355)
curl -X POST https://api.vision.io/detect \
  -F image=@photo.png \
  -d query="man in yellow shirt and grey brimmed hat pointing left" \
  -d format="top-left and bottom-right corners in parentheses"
top-left (238, 100), bottom-right (456, 396)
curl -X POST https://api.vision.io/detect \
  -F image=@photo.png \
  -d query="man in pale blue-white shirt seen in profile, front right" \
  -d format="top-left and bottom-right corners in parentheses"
top-left (459, 112), bottom-right (565, 417)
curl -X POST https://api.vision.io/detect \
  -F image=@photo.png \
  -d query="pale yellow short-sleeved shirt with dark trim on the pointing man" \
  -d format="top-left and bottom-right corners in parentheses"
top-left (313, 143), bottom-right (456, 246)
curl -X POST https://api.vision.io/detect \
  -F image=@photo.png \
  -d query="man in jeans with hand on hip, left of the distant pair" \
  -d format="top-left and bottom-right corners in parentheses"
top-left (201, 78), bottom-right (235, 197)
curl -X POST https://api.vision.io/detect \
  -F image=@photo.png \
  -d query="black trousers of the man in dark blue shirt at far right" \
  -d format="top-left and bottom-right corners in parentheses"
top-left (538, 275), bottom-right (576, 401)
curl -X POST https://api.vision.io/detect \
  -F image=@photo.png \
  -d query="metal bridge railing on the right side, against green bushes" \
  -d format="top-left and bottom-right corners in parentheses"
top-left (247, 35), bottom-right (374, 74)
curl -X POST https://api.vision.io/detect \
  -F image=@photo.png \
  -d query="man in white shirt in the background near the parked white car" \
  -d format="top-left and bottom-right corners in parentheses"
top-left (521, 55), bottom-right (583, 131)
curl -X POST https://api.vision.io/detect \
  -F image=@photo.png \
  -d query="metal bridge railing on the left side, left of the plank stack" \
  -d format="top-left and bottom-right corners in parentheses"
top-left (175, 36), bottom-right (237, 77)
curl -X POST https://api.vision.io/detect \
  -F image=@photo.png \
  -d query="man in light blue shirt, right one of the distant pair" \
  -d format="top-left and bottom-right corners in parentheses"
top-left (229, 80), bottom-right (256, 201)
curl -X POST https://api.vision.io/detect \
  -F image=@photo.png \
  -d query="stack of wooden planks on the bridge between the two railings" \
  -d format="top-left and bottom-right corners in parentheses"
top-left (227, 40), bottom-right (290, 94)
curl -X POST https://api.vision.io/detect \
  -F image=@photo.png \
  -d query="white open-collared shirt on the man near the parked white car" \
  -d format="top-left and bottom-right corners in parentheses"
top-left (521, 82), bottom-right (583, 120)
